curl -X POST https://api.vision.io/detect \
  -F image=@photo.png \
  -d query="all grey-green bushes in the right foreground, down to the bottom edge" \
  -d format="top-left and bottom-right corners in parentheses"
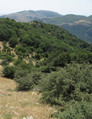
top-left (39, 63), bottom-right (92, 119)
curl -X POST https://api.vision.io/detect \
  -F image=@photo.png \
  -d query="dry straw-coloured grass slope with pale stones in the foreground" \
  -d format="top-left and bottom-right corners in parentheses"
top-left (0, 77), bottom-right (55, 119)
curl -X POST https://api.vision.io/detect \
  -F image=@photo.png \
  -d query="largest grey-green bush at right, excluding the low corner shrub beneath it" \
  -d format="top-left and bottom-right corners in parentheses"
top-left (40, 63), bottom-right (92, 105)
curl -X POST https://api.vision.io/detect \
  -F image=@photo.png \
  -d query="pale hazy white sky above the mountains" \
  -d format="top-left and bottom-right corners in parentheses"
top-left (0, 0), bottom-right (92, 16)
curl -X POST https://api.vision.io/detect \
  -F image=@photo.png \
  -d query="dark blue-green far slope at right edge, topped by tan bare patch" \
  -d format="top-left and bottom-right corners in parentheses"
top-left (62, 21), bottom-right (92, 43)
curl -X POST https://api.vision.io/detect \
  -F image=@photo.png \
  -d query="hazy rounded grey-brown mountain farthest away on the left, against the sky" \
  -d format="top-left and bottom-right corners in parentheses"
top-left (2, 10), bottom-right (61, 22)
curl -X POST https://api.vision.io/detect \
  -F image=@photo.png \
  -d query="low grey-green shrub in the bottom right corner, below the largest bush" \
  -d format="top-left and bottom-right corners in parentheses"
top-left (53, 101), bottom-right (92, 119)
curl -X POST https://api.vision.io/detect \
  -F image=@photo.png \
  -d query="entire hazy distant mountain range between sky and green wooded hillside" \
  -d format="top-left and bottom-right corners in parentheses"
top-left (1, 10), bottom-right (92, 43)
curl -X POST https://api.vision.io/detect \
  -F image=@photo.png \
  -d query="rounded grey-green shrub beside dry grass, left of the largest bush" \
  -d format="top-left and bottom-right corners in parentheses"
top-left (15, 71), bottom-right (41, 91)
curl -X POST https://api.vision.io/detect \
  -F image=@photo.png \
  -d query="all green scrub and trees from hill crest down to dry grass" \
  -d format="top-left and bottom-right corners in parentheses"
top-left (0, 18), bottom-right (92, 119)
